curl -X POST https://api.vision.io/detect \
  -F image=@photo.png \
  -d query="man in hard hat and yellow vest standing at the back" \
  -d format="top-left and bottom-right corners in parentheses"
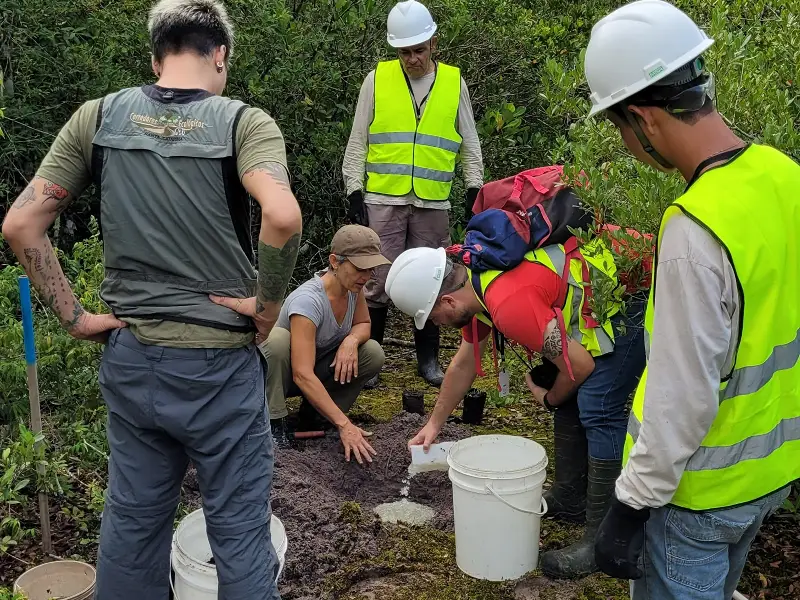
top-left (342, 0), bottom-right (483, 387)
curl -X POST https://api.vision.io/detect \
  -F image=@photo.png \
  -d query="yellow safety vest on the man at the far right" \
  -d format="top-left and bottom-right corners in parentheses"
top-left (623, 145), bottom-right (800, 510)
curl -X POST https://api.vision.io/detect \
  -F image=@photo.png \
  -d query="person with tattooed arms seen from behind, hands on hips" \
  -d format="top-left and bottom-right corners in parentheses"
top-left (3, 0), bottom-right (302, 600)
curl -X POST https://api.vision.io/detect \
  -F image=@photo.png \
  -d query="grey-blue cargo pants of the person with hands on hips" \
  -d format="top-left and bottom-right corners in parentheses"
top-left (95, 329), bottom-right (280, 600)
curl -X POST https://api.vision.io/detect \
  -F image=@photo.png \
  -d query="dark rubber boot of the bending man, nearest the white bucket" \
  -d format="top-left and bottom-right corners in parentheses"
top-left (540, 457), bottom-right (622, 579)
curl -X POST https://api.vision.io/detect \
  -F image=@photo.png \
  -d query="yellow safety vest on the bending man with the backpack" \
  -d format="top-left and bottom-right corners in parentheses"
top-left (469, 238), bottom-right (622, 356)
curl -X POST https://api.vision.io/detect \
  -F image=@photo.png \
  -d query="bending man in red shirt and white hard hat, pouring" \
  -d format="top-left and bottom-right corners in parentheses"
top-left (386, 237), bottom-right (645, 578)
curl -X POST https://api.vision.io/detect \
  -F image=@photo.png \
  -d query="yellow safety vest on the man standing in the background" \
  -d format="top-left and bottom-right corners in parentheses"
top-left (366, 60), bottom-right (461, 200)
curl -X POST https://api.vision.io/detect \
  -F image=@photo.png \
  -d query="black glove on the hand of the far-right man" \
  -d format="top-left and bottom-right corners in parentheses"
top-left (594, 496), bottom-right (650, 579)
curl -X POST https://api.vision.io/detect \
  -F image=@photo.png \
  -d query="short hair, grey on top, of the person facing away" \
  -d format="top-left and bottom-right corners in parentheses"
top-left (147, 0), bottom-right (233, 61)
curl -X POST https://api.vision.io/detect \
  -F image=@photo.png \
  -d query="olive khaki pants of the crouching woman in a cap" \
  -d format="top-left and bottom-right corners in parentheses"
top-left (263, 327), bottom-right (384, 419)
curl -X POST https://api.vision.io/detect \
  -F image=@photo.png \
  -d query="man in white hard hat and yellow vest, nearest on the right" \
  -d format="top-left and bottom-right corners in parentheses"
top-left (585, 0), bottom-right (800, 600)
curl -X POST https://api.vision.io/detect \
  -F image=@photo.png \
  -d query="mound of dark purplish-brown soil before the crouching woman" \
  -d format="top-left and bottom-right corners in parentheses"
top-left (272, 413), bottom-right (469, 600)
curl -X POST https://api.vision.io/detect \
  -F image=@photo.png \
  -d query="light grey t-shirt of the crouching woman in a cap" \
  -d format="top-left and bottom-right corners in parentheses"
top-left (275, 271), bottom-right (358, 356)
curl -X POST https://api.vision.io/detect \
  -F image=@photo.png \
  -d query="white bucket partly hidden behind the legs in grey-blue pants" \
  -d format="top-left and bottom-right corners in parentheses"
top-left (172, 508), bottom-right (288, 600)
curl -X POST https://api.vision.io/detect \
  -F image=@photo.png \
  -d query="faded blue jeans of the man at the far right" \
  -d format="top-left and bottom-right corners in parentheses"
top-left (631, 487), bottom-right (789, 600)
